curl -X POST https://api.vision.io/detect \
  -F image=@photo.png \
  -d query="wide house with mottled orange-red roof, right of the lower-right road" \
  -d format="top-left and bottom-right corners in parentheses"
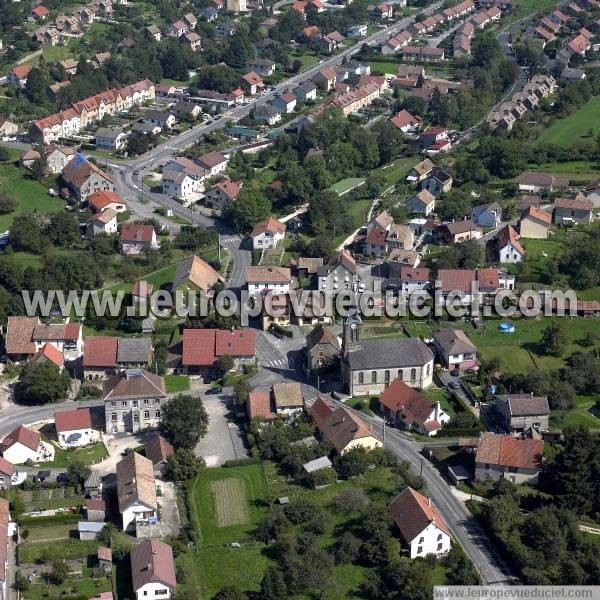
top-left (475, 432), bottom-right (544, 485)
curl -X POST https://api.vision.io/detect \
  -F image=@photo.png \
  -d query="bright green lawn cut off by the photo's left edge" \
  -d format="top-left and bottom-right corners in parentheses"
top-left (0, 163), bottom-right (65, 231)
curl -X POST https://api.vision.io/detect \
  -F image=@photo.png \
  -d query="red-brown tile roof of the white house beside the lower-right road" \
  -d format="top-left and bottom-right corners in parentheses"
top-left (388, 487), bottom-right (450, 543)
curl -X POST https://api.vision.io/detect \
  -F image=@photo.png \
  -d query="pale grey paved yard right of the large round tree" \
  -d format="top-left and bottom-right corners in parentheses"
top-left (196, 394), bottom-right (250, 467)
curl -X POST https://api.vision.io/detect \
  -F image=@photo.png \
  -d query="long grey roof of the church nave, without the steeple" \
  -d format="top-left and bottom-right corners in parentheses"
top-left (347, 338), bottom-right (433, 371)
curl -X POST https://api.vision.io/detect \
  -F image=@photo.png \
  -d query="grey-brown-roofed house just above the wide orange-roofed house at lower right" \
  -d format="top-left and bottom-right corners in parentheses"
top-left (494, 394), bottom-right (550, 433)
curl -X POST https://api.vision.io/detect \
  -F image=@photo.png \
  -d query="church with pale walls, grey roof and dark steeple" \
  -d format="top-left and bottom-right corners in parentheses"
top-left (341, 309), bottom-right (434, 396)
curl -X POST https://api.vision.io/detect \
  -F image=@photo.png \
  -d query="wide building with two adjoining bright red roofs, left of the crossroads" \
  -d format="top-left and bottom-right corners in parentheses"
top-left (176, 329), bottom-right (256, 377)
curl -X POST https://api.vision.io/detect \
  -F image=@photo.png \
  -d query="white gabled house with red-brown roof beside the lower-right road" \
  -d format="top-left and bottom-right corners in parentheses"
top-left (388, 487), bottom-right (450, 558)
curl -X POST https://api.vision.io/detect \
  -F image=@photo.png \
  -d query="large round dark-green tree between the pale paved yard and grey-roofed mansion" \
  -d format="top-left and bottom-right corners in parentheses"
top-left (160, 394), bottom-right (209, 448)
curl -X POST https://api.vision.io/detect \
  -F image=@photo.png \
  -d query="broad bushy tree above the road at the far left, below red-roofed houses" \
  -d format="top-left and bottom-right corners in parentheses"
top-left (15, 362), bottom-right (71, 405)
